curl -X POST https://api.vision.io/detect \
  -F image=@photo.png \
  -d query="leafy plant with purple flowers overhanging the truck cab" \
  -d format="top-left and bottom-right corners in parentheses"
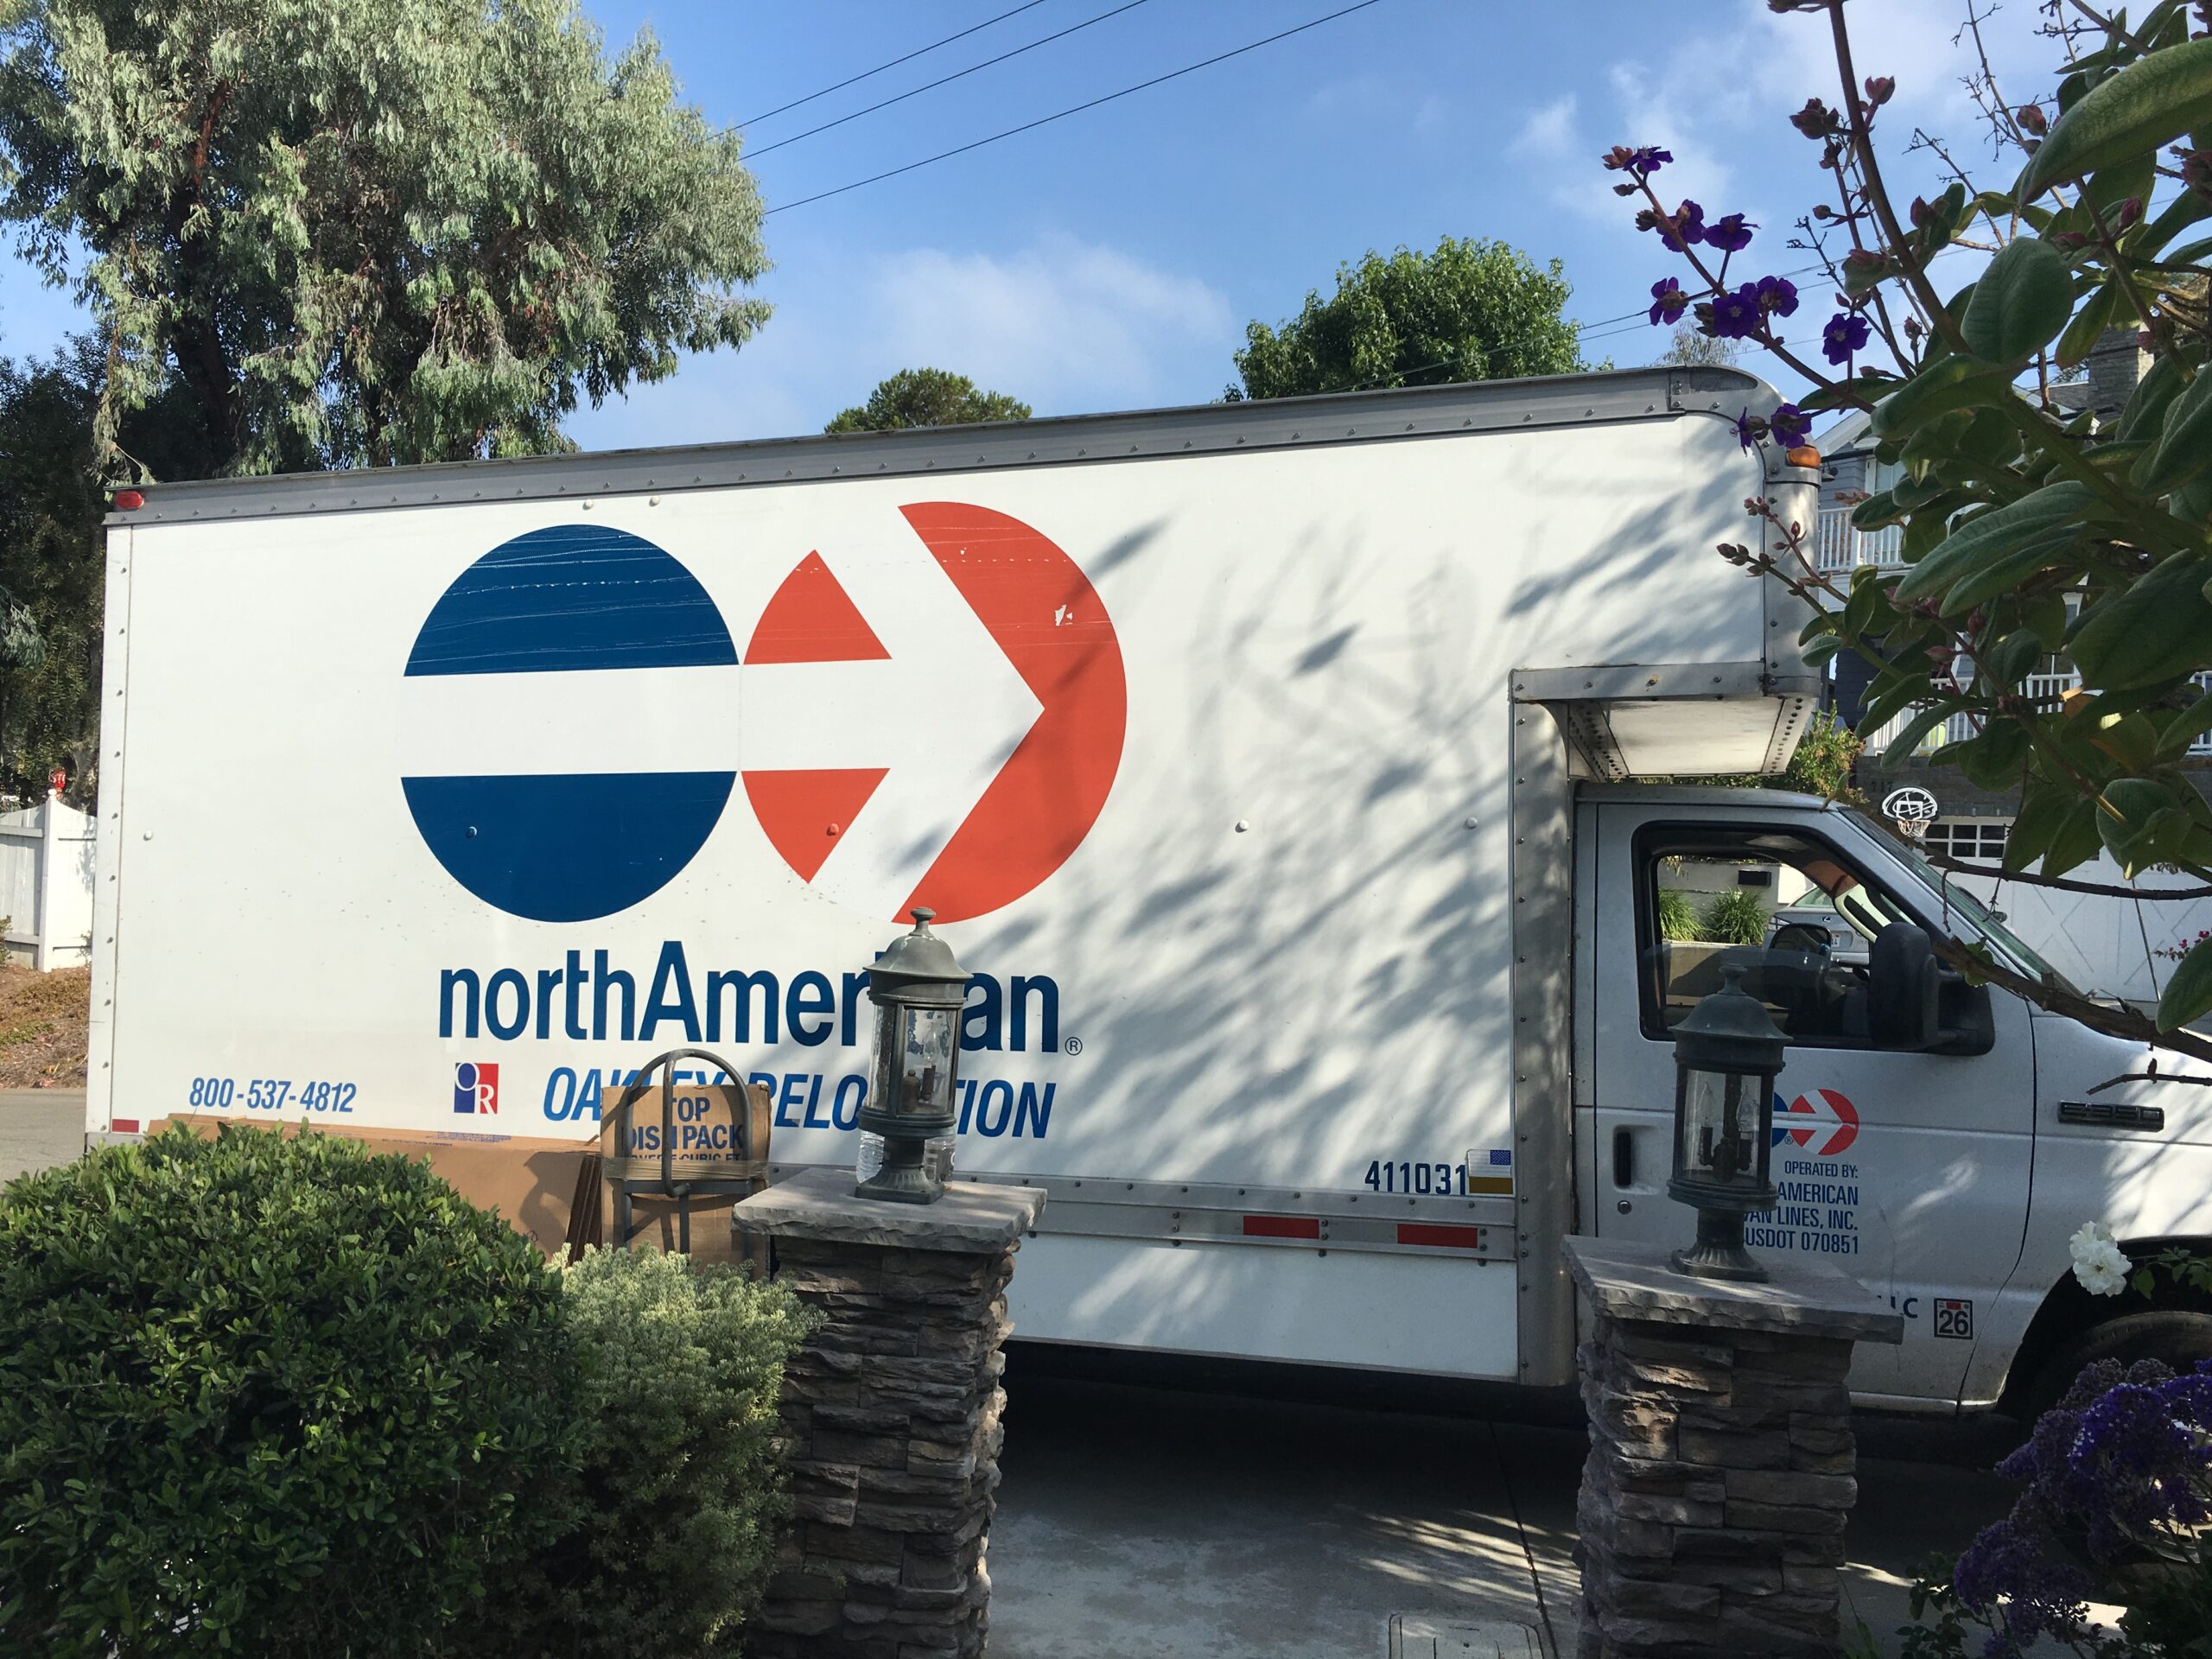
top-left (1604, 0), bottom-right (2212, 1059)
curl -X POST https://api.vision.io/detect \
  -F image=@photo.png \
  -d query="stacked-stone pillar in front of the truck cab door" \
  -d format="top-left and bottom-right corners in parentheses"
top-left (1566, 1239), bottom-right (1904, 1659)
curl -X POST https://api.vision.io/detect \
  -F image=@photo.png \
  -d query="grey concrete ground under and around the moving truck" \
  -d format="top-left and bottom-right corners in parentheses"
top-left (0, 1089), bottom-right (2018, 1659)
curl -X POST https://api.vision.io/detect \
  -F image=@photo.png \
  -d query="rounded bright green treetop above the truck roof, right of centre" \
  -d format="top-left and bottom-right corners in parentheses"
top-left (1225, 237), bottom-right (1591, 403)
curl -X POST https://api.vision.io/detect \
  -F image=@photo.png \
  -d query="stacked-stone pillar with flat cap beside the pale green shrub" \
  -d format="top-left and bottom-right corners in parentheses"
top-left (732, 1168), bottom-right (1044, 1659)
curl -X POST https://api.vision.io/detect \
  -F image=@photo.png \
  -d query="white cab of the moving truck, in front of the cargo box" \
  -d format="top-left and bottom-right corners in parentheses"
top-left (1573, 783), bottom-right (2212, 1411)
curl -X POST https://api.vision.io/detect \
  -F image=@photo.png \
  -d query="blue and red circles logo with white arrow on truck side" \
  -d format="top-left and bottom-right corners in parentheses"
top-left (400, 502), bottom-right (1128, 923)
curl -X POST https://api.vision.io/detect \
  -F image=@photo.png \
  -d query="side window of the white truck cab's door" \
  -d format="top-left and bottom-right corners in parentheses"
top-left (1637, 825), bottom-right (1911, 1046)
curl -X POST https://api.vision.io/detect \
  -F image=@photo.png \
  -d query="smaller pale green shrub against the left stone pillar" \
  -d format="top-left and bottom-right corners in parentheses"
top-left (513, 1249), bottom-right (817, 1659)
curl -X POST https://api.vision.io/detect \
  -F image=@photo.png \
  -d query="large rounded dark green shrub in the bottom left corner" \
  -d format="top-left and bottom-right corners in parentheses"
top-left (0, 1126), bottom-right (580, 1659)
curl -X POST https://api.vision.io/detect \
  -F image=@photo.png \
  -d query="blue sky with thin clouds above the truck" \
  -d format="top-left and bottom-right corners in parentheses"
top-left (0, 0), bottom-right (2050, 449)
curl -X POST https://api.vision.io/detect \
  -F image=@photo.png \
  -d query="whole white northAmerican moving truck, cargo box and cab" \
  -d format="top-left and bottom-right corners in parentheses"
top-left (88, 370), bottom-right (2212, 1411)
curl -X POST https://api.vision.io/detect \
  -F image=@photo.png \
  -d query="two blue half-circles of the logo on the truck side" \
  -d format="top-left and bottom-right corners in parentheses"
top-left (400, 524), bottom-right (736, 923)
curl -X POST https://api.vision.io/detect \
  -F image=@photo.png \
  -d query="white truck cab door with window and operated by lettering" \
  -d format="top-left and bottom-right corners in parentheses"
top-left (1584, 801), bottom-right (2035, 1405)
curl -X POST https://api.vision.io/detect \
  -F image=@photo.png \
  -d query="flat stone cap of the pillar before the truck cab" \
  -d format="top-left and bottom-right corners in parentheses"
top-left (1560, 1239), bottom-right (1904, 1343)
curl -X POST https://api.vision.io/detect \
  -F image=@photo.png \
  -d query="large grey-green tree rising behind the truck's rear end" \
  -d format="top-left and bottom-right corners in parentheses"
top-left (0, 0), bottom-right (767, 478)
